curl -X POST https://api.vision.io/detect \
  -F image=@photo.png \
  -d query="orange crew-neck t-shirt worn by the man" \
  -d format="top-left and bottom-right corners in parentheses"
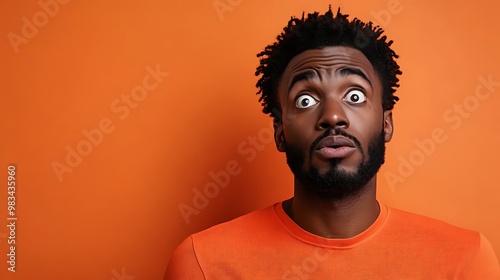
top-left (165, 203), bottom-right (500, 280)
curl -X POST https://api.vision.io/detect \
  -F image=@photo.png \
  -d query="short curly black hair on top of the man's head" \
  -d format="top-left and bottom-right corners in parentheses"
top-left (255, 6), bottom-right (402, 120)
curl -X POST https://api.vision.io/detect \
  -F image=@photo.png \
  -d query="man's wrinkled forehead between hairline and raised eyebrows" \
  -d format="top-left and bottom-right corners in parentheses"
top-left (279, 46), bottom-right (380, 88)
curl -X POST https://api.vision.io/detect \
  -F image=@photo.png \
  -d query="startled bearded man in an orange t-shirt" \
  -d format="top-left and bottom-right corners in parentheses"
top-left (165, 9), bottom-right (500, 280)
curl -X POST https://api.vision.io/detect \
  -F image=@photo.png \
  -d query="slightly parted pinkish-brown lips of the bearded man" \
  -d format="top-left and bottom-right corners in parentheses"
top-left (314, 136), bottom-right (356, 160)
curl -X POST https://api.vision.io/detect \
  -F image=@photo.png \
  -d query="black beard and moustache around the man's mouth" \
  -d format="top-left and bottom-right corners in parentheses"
top-left (285, 129), bottom-right (385, 201)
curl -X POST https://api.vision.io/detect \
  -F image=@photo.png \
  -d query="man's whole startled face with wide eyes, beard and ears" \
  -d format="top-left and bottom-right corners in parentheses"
top-left (275, 46), bottom-right (393, 199)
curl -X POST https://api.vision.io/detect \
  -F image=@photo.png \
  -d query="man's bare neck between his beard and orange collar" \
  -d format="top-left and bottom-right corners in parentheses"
top-left (283, 177), bottom-right (380, 238)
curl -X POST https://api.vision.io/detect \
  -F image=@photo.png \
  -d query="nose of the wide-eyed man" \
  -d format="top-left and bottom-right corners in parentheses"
top-left (316, 98), bottom-right (349, 130)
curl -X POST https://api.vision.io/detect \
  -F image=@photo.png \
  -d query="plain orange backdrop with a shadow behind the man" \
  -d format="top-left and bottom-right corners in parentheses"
top-left (0, 0), bottom-right (500, 280)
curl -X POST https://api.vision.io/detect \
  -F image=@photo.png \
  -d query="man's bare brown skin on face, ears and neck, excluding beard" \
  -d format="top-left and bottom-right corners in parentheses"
top-left (274, 46), bottom-right (393, 238)
